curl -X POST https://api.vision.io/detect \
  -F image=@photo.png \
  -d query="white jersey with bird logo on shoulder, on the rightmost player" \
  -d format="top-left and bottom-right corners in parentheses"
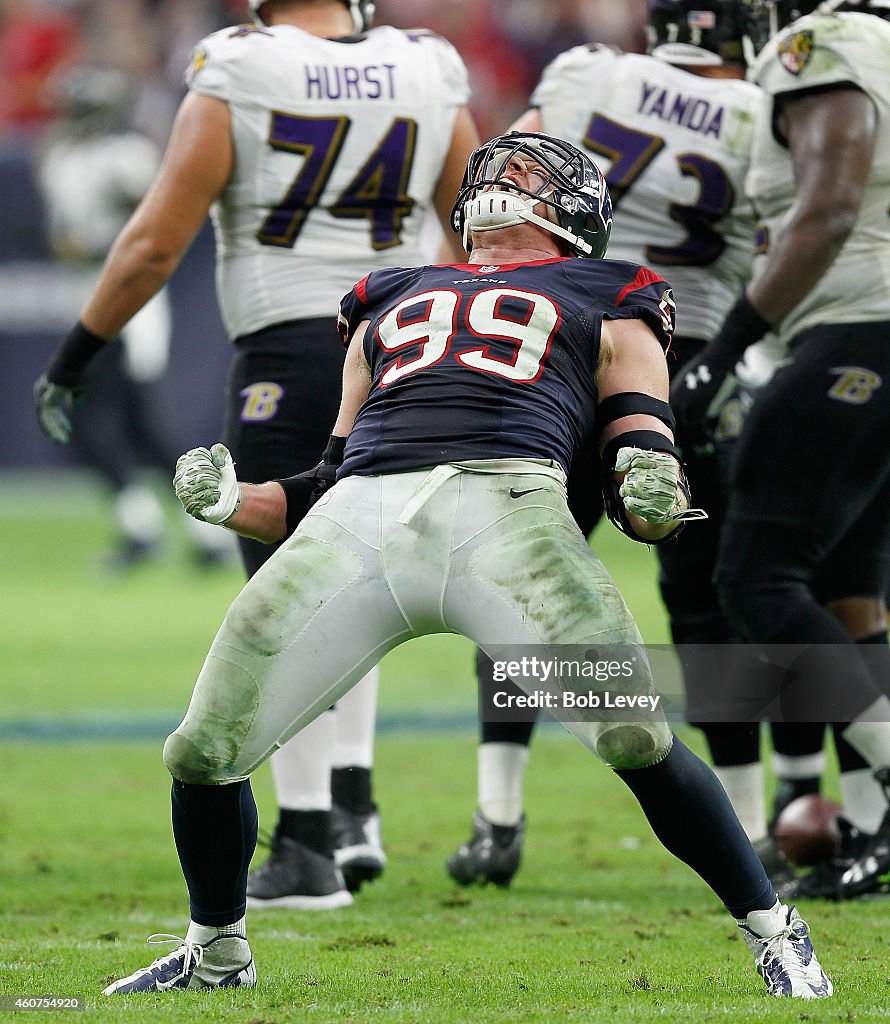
top-left (748, 13), bottom-right (890, 341)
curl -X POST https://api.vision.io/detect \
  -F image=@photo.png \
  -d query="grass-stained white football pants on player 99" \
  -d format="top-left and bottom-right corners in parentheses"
top-left (164, 459), bottom-right (671, 784)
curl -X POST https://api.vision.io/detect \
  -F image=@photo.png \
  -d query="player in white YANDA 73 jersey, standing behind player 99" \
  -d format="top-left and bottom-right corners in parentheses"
top-left (447, 0), bottom-right (823, 892)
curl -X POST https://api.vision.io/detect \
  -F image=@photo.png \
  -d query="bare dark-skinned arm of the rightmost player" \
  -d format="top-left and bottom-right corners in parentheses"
top-left (749, 88), bottom-right (877, 324)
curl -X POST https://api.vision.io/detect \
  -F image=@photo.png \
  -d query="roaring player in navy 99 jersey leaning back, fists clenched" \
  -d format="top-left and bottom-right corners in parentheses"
top-left (97, 133), bottom-right (832, 998)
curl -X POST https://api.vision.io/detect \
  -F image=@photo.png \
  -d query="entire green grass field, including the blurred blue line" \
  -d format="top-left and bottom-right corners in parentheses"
top-left (0, 468), bottom-right (890, 1024)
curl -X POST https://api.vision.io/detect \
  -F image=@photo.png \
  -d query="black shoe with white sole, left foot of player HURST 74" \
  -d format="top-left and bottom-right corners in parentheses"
top-left (247, 829), bottom-right (352, 910)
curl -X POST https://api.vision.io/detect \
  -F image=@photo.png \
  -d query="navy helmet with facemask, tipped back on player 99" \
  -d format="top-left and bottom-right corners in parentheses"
top-left (452, 132), bottom-right (611, 259)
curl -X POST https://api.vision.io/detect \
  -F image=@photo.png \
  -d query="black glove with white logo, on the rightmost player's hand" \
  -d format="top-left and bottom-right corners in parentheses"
top-left (671, 293), bottom-right (771, 447)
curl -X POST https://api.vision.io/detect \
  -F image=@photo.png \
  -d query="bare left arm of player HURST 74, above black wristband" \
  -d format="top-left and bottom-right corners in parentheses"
top-left (81, 93), bottom-right (232, 340)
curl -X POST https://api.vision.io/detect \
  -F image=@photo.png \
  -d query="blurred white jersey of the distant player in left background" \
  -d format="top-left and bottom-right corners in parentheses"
top-left (38, 132), bottom-right (161, 261)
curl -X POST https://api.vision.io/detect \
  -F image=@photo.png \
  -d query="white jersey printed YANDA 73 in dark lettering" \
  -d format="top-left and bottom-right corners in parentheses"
top-left (532, 44), bottom-right (763, 340)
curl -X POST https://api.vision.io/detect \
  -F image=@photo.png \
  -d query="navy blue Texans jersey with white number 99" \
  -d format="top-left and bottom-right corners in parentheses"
top-left (338, 257), bottom-right (674, 477)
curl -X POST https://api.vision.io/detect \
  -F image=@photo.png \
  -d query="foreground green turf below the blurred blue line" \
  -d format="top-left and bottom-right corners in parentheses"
top-left (8, 729), bottom-right (890, 1024)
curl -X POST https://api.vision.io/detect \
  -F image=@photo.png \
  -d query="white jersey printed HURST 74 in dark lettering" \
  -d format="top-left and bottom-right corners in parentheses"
top-left (186, 25), bottom-right (469, 338)
